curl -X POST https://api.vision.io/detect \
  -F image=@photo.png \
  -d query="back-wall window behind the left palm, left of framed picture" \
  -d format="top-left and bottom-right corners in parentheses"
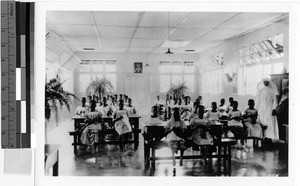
top-left (78, 60), bottom-right (117, 94)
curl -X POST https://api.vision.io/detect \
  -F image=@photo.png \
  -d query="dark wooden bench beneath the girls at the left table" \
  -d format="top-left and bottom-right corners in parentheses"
top-left (69, 129), bottom-right (142, 155)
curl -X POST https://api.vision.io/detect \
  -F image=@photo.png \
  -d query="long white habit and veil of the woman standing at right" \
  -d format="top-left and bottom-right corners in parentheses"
top-left (256, 85), bottom-right (279, 139)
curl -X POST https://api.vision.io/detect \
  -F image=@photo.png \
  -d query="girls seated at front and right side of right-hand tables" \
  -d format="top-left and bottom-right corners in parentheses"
top-left (159, 96), bottom-right (262, 165)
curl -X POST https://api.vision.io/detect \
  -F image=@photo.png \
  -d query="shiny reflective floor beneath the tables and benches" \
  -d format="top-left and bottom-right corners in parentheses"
top-left (49, 117), bottom-right (288, 176)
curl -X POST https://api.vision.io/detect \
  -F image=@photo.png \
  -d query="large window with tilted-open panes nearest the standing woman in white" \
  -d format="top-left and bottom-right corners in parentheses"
top-left (237, 34), bottom-right (284, 95)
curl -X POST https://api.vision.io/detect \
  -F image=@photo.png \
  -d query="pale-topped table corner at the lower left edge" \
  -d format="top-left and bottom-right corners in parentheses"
top-left (45, 144), bottom-right (60, 176)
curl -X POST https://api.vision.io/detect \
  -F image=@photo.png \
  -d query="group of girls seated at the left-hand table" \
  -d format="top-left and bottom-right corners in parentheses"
top-left (75, 94), bottom-right (136, 151)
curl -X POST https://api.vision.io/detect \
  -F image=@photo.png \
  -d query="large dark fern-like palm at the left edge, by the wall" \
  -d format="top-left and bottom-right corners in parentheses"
top-left (45, 75), bottom-right (77, 121)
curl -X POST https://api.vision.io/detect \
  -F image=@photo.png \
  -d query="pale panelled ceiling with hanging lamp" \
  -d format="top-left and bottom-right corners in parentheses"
top-left (47, 11), bottom-right (287, 53)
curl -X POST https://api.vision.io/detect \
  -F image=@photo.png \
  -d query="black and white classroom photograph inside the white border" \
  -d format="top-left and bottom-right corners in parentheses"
top-left (44, 10), bottom-right (290, 177)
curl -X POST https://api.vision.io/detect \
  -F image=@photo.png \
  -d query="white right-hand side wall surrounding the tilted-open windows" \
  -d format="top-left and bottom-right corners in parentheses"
top-left (198, 19), bottom-right (289, 111)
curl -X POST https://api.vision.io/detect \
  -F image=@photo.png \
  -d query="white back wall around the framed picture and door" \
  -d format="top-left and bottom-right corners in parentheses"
top-left (74, 52), bottom-right (199, 104)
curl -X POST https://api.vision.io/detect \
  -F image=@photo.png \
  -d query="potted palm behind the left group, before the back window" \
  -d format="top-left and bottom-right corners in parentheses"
top-left (86, 78), bottom-right (113, 97)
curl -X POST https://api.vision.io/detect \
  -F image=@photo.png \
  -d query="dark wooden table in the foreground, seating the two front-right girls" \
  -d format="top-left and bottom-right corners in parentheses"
top-left (142, 119), bottom-right (236, 175)
